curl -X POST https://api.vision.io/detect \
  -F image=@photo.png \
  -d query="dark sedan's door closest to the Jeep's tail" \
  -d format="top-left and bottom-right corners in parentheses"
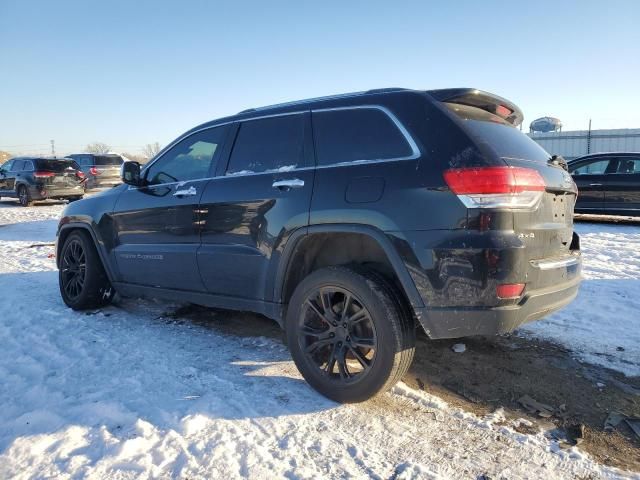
top-left (569, 157), bottom-right (611, 213)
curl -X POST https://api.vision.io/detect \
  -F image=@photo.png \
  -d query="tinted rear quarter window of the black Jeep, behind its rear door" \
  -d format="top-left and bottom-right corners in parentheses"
top-left (313, 108), bottom-right (413, 165)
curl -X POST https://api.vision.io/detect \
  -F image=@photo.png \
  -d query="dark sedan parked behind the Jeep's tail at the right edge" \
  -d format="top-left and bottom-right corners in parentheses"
top-left (569, 152), bottom-right (640, 215)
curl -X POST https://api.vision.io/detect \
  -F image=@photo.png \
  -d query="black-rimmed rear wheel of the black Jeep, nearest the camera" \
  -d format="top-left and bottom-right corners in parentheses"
top-left (285, 267), bottom-right (415, 403)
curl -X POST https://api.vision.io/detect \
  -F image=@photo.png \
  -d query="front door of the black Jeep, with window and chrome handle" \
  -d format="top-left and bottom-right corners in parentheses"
top-left (113, 127), bottom-right (228, 291)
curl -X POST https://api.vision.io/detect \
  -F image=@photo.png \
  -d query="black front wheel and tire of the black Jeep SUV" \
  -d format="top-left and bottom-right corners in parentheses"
top-left (58, 230), bottom-right (115, 310)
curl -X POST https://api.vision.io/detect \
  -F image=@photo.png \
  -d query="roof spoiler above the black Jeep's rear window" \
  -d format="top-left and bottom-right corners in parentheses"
top-left (427, 88), bottom-right (524, 127)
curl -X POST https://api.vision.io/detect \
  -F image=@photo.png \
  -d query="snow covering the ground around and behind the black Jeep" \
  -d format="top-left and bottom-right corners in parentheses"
top-left (0, 202), bottom-right (640, 479)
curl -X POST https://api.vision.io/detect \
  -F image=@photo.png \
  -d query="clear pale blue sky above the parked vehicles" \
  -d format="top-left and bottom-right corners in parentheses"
top-left (0, 0), bottom-right (640, 153)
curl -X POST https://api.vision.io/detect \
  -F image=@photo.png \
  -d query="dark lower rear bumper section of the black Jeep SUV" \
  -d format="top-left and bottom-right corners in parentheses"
top-left (419, 263), bottom-right (581, 339)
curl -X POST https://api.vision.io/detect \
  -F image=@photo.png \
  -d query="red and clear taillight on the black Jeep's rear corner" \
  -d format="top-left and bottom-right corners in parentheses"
top-left (444, 166), bottom-right (545, 209)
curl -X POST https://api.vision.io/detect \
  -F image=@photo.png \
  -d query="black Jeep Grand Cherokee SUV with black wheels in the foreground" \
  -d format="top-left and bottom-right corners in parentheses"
top-left (57, 89), bottom-right (581, 402)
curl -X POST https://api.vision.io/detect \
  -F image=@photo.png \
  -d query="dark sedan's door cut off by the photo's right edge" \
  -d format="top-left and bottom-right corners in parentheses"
top-left (603, 155), bottom-right (640, 214)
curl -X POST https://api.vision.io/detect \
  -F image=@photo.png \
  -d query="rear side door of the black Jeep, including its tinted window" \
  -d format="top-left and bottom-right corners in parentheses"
top-left (198, 112), bottom-right (314, 301)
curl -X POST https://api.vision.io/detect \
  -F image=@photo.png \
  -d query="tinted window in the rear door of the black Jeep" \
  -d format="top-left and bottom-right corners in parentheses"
top-left (227, 115), bottom-right (305, 175)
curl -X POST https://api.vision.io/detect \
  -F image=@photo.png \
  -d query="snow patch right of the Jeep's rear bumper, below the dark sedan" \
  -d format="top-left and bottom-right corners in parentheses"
top-left (523, 223), bottom-right (640, 376)
